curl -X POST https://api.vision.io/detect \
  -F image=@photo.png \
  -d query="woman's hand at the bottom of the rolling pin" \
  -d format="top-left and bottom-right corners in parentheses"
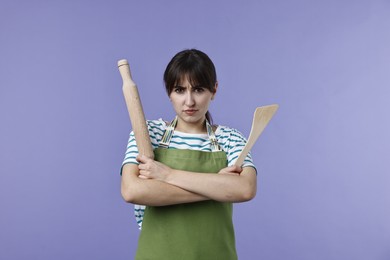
top-left (137, 155), bottom-right (172, 181)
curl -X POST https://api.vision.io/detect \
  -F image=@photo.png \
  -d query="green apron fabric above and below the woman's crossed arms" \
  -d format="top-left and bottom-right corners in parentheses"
top-left (135, 121), bottom-right (237, 260)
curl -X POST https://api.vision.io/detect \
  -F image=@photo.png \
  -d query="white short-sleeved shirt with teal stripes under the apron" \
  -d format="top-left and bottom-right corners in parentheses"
top-left (122, 119), bottom-right (255, 228)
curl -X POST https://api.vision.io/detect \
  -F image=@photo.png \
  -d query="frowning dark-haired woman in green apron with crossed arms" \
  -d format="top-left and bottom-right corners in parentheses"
top-left (121, 49), bottom-right (256, 260)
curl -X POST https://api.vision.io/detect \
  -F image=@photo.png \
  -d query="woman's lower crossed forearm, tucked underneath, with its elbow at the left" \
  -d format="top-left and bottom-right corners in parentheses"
top-left (121, 165), bottom-right (208, 206)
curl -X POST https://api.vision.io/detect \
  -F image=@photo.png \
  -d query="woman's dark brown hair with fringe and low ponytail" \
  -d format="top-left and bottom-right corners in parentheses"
top-left (164, 49), bottom-right (217, 124)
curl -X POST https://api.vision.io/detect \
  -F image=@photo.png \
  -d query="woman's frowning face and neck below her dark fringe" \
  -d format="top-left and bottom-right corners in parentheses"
top-left (169, 77), bottom-right (217, 131)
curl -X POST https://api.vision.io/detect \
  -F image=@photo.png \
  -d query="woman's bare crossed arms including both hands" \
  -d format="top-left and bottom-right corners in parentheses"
top-left (121, 156), bottom-right (256, 206)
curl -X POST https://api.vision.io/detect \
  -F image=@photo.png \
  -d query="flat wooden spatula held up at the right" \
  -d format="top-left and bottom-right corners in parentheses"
top-left (234, 104), bottom-right (279, 166)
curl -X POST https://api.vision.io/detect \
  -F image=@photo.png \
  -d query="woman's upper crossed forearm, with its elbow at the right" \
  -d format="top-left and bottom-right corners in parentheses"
top-left (164, 167), bottom-right (256, 202)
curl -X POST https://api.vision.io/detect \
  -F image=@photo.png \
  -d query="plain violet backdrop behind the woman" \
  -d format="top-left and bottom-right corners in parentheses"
top-left (0, 0), bottom-right (390, 260)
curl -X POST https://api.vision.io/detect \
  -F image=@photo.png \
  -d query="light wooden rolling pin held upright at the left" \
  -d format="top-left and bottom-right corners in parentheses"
top-left (118, 60), bottom-right (154, 159)
